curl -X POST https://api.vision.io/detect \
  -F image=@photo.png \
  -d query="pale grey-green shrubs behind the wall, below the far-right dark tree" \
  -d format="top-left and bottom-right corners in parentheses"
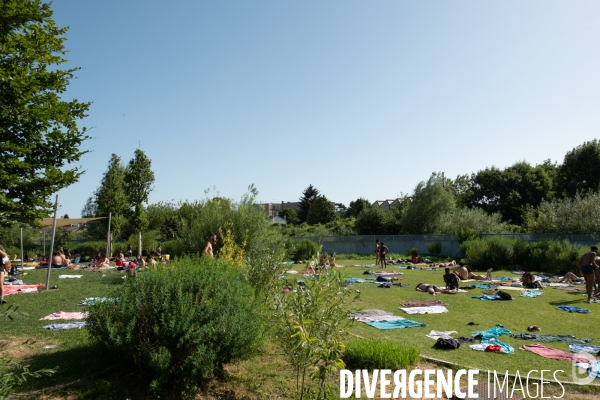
top-left (524, 192), bottom-right (600, 233)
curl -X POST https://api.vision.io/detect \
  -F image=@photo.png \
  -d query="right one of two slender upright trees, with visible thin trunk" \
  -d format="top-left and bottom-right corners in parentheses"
top-left (125, 149), bottom-right (154, 254)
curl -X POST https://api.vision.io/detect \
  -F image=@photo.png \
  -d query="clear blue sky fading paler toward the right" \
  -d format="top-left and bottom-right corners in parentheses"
top-left (53, 0), bottom-right (600, 217)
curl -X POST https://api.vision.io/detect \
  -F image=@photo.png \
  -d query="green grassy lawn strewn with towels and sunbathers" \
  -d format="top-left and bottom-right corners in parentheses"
top-left (0, 260), bottom-right (600, 399)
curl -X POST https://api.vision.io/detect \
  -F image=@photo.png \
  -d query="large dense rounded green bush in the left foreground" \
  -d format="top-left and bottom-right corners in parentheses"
top-left (89, 258), bottom-right (266, 395)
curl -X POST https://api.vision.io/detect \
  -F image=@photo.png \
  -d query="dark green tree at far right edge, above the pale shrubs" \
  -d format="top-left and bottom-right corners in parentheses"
top-left (557, 139), bottom-right (600, 198)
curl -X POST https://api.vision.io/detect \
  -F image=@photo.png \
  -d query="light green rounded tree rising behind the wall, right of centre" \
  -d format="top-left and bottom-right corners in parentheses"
top-left (400, 174), bottom-right (455, 234)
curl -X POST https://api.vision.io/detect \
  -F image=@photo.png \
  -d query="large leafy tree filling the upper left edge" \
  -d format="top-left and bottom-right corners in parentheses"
top-left (0, 0), bottom-right (90, 226)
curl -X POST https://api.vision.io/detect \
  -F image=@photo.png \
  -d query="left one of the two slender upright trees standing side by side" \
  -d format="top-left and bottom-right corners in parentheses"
top-left (95, 154), bottom-right (129, 237)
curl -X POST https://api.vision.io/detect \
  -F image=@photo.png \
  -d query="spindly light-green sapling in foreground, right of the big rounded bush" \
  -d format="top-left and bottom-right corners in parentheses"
top-left (275, 274), bottom-right (353, 399)
